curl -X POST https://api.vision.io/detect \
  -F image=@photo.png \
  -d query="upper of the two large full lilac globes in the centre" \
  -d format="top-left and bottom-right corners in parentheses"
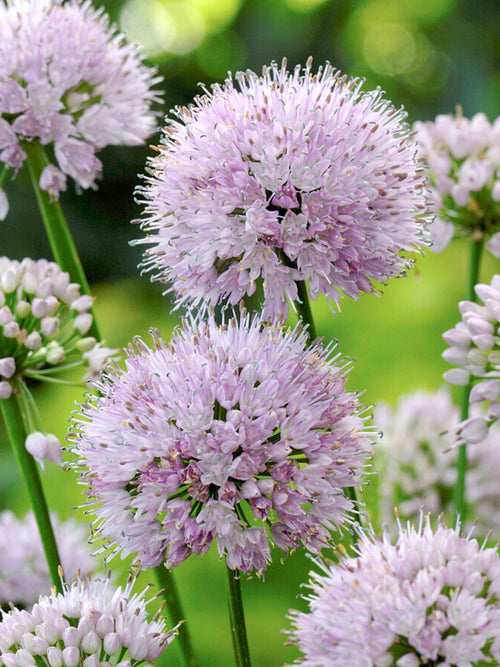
top-left (139, 62), bottom-right (426, 317)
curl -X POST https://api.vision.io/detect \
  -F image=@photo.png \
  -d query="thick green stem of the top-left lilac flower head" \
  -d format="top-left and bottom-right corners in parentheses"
top-left (23, 141), bottom-right (101, 340)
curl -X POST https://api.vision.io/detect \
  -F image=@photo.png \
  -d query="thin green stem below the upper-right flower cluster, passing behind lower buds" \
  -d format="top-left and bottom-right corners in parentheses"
top-left (453, 239), bottom-right (484, 525)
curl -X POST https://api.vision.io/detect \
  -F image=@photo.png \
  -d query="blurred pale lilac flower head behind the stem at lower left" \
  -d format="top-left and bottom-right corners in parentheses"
top-left (0, 510), bottom-right (98, 608)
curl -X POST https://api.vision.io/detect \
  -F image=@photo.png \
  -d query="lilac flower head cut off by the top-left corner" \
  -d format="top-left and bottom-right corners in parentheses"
top-left (0, 0), bottom-right (158, 212)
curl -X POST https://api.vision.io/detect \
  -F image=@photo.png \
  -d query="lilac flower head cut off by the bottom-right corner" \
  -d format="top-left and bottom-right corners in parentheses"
top-left (290, 518), bottom-right (500, 667)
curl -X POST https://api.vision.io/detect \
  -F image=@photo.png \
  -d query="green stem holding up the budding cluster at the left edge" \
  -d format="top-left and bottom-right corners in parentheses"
top-left (0, 394), bottom-right (63, 592)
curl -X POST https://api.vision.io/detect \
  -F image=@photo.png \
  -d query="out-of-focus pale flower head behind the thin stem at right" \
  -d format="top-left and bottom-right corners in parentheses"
top-left (374, 389), bottom-right (500, 536)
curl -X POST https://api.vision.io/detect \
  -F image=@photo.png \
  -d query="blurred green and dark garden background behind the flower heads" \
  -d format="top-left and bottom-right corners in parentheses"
top-left (0, 0), bottom-right (500, 667)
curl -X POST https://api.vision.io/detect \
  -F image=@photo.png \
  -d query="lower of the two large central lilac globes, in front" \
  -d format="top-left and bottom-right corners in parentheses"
top-left (74, 316), bottom-right (371, 572)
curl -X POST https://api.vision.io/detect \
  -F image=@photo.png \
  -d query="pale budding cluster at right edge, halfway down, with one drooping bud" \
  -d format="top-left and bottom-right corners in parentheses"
top-left (443, 275), bottom-right (500, 442)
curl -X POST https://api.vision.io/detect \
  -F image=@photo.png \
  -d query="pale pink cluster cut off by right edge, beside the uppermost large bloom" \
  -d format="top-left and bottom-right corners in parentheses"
top-left (415, 108), bottom-right (500, 257)
